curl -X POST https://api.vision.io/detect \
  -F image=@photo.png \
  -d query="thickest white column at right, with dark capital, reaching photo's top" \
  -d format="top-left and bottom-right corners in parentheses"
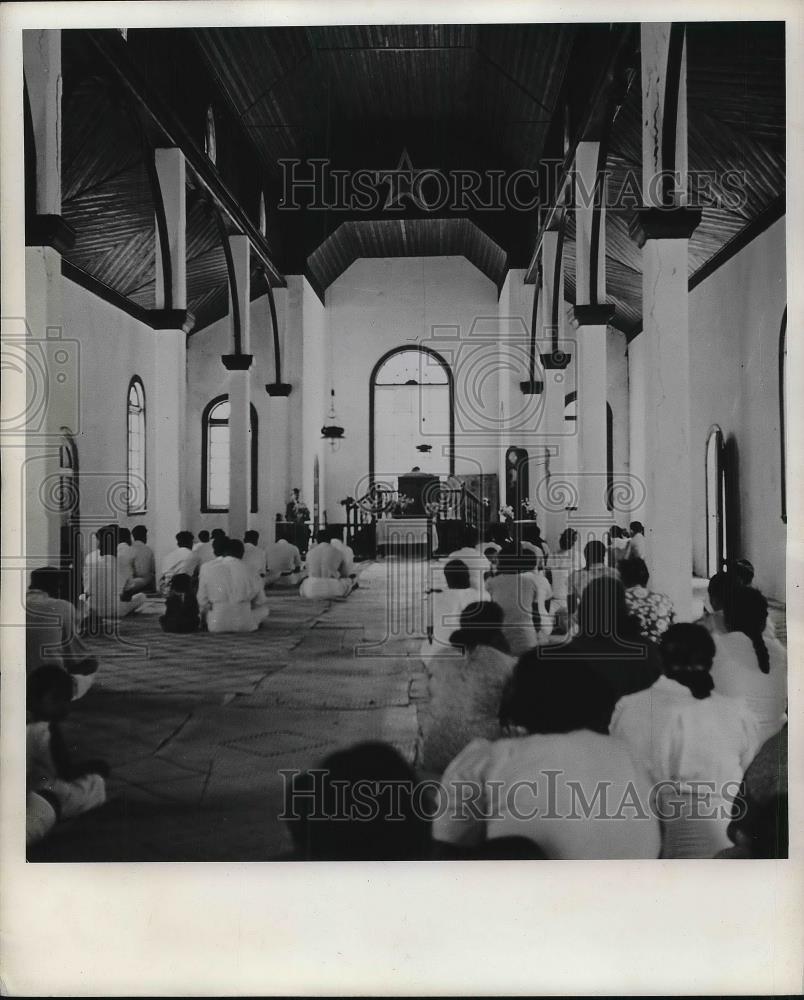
top-left (631, 23), bottom-right (701, 620)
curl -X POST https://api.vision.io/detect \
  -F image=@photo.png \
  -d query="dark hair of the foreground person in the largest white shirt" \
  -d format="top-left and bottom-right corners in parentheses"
top-left (500, 649), bottom-right (617, 733)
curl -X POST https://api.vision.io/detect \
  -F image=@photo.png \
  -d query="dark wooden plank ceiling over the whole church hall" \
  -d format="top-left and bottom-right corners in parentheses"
top-left (51, 23), bottom-right (785, 335)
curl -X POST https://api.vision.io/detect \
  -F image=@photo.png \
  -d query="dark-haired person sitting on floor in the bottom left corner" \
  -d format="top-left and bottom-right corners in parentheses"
top-left (25, 665), bottom-right (109, 846)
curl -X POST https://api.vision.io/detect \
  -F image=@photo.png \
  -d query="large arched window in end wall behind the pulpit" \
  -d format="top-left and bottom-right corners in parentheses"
top-left (369, 347), bottom-right (455, 483)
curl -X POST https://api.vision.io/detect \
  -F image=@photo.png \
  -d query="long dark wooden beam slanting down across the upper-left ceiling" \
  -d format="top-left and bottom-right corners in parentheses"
top-left (87, 29), bottom-right (286, 288)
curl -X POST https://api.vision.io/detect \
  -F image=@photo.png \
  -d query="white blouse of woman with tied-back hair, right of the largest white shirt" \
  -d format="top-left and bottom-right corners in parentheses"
top-left (609, 677), bottom-right (760, 798)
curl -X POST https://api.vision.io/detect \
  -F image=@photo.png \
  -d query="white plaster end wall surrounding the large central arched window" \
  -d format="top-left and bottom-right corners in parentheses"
top-left (326, 257), bottom-right (499, 521)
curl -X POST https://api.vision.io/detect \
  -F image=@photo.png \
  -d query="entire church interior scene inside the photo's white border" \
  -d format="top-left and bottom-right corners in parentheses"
top-left (20, 22), bottom-right (788, 862)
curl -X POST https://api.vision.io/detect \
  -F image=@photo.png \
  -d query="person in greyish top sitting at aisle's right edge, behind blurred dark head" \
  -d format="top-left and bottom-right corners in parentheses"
top-left (419, 601), bottom-right (514, 775)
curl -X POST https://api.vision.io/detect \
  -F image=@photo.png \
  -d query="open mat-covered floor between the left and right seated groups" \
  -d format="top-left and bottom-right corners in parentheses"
top-left (30, 558), bottom-right (434, 861)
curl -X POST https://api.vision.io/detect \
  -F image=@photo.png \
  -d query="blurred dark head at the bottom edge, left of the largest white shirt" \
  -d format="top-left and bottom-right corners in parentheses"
top-left (282, 742), bottom-right (430, 861)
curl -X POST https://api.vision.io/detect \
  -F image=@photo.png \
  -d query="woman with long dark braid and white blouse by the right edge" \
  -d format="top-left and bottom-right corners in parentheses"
top-left (712, 587), bottom-right (787, 742)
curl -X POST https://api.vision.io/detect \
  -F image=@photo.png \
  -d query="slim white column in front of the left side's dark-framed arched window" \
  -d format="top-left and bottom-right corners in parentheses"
top-left (228, 235), bottom-right (251, 538)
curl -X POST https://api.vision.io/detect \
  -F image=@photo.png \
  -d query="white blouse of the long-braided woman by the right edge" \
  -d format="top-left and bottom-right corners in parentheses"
top-left (712, 632), bottom-right (787, 744)
